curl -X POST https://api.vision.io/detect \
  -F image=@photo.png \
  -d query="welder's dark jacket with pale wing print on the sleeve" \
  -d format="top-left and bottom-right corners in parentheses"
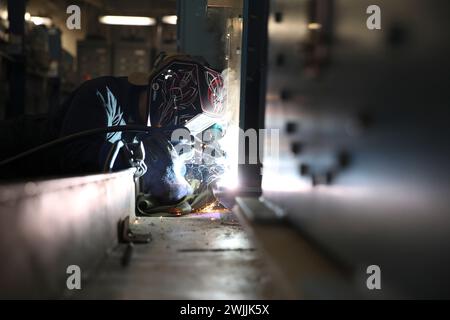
top-left (0, 77), bottom-right (192, 202)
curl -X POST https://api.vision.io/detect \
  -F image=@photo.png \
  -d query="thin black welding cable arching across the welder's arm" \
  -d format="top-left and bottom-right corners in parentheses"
top-left (0, 125), bottom-right (179, 167)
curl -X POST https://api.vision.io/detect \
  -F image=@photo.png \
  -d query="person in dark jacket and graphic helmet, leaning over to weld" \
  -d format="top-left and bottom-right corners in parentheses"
top-left (0, 54), bottom-right (225, 204)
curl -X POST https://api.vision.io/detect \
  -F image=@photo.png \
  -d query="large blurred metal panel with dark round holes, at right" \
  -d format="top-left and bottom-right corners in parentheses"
top-left (263, 0), bottom-right (450, 297)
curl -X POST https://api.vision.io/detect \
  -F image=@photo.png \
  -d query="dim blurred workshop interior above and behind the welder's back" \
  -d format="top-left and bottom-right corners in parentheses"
top-left (0, 0), bottom-right (177, 118)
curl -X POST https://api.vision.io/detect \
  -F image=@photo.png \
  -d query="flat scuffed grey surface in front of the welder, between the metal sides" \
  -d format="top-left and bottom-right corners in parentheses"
top-left (72, 212), bottom-right (285, 299)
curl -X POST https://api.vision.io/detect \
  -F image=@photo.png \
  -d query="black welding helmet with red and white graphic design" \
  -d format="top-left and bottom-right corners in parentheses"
top-left (148, 54), bottom-right (226, 135)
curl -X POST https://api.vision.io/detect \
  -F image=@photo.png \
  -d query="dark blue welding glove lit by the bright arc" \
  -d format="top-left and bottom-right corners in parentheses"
top-left (142, 134), bottom-right (192, 205)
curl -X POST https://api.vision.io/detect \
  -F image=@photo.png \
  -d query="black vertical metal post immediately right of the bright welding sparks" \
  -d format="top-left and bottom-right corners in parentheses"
top-left (238, 0), bottom-right (269, 194)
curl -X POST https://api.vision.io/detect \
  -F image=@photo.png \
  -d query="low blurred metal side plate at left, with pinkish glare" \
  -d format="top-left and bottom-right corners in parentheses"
top-left (0, 170), bottom-right (134, 298)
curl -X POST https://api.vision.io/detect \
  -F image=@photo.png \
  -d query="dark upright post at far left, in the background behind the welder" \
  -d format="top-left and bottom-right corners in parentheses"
top-left (6, 0), bottom-right (26, 117)
